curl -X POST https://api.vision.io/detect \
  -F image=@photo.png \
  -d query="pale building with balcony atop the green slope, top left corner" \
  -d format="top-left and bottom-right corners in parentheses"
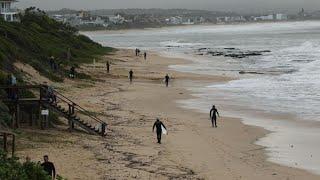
top-left (0, 0), bottom-right (18, 22)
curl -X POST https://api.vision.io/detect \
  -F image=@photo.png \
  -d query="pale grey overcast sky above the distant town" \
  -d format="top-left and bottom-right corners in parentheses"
top-left (17, 0), bottom-right (320, 12)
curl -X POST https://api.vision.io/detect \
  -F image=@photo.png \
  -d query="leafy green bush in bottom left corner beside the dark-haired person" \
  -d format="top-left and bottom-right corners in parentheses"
top-left (0, 150), bottom-right (51, 180)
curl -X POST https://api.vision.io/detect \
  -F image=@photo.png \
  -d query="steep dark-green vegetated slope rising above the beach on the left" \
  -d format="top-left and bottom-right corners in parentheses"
top-left (0, 8), bottom-right (112, 81)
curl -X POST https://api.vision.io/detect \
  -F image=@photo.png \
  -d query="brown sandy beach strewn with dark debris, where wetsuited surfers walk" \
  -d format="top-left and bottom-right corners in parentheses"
top-left (17, 50), bottom-right (320, 180)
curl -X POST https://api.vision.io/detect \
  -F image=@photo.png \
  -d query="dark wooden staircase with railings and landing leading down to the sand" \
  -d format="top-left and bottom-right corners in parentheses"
top-left (0, 85), bottom-right (107, 136)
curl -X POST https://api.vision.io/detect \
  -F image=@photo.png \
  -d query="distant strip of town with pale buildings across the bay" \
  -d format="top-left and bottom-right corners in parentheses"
top-left (47, 8), bottom-right (320, 30)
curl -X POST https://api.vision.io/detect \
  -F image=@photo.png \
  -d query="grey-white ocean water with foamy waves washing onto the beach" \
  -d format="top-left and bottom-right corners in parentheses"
top-left (85, 21), bottom-right (320, 174)
